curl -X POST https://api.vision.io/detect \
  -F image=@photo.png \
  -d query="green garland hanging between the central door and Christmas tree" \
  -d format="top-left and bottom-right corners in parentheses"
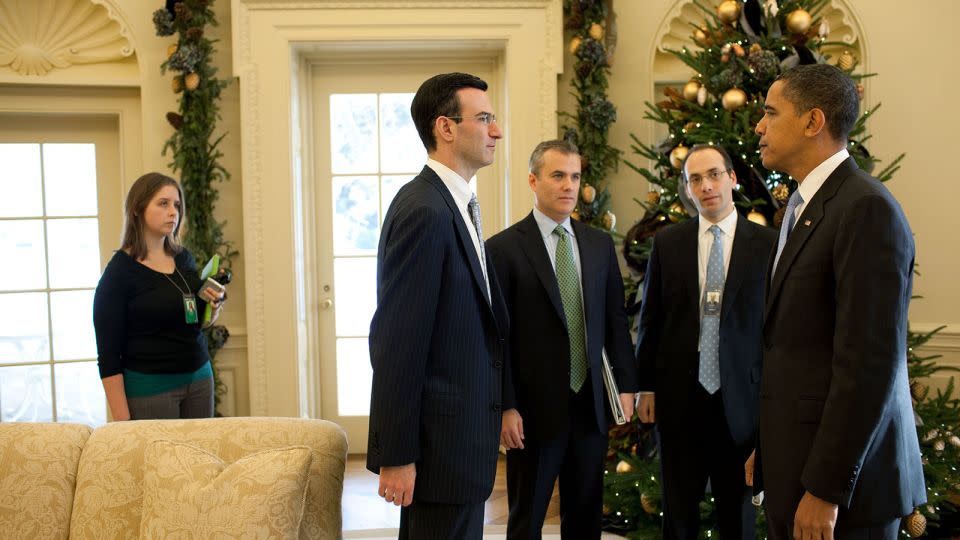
top-left (560, 0), bottom-right (620, 231)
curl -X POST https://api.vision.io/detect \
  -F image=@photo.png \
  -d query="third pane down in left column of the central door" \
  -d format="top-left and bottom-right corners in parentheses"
top-left (333, 257), bottom-right (377, 336)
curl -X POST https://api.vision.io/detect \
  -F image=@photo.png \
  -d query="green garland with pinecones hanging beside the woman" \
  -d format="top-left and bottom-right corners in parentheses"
top-left (153, 0), bottom-right (238, 404)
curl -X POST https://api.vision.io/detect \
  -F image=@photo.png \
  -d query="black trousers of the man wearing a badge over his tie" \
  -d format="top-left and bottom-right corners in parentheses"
top-left (657, 381), bottom-right (756, 540)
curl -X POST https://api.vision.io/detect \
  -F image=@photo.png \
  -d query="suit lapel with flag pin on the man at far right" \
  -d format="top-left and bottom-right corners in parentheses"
top-left (764, 157), bottom-right (857, 320)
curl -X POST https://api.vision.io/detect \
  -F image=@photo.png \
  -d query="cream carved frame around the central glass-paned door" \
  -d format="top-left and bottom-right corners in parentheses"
top-left (231, 0), bottom-right (563, 416)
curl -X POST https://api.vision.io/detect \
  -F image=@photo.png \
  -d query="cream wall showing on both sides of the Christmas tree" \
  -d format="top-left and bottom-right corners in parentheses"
top-left (558, 0), bottom-right (960, 372)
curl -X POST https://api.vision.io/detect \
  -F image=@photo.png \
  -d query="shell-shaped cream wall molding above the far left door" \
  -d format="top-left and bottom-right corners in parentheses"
top-left (0, 0), bottom-right (135, 76)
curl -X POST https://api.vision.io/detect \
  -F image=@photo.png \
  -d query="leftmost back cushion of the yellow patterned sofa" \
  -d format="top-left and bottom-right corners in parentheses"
top-left (0, 423), bottom-right (90, 539)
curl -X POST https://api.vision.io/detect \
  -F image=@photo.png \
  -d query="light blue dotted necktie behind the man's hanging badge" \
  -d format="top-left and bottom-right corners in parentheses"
top-left (699, 225), bottom-right (723, 394)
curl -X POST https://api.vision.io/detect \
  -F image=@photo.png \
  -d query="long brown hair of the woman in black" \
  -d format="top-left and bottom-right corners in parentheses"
top-left (120, 172), bottom-right (187, 261)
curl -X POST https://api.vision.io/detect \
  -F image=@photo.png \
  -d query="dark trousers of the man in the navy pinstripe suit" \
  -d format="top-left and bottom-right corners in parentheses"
top-left (397, 500), bottom-right (483, 540)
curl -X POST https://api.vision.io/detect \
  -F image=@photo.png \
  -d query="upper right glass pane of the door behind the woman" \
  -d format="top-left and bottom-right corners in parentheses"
top-left (43, 143), bottom-right (97, 216)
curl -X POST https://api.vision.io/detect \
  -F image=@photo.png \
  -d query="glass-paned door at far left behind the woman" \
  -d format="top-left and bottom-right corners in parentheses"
top-left (0, 114), bottom-right (119, 426)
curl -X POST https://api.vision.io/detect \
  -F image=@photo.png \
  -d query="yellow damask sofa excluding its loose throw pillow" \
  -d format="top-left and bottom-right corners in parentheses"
top-left (0, 417), bottom-right (347, 540)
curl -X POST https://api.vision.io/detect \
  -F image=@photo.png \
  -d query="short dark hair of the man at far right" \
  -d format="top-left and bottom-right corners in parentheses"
top-left (777, 64), bottom-right (860, 143)
